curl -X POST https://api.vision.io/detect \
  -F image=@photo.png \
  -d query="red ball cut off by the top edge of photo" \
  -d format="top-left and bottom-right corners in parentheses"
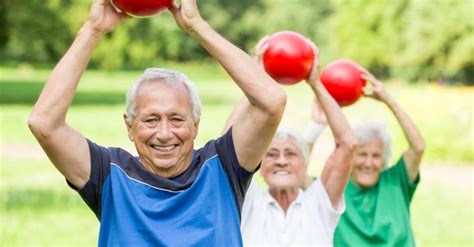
top-left (110, 0), bottom-right (173, 17)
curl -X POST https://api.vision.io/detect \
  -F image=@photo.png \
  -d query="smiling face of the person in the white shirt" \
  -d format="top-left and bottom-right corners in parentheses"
top-left (261, 137), bottom-right (306, 189)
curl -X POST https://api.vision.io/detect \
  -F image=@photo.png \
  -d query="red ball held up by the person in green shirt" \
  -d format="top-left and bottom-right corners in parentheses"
top-left (320, 60), bottom-right (366, 106)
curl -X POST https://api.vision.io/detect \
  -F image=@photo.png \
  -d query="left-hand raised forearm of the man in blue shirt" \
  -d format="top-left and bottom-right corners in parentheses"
top-left (30, 25), bottom-right (101, 133)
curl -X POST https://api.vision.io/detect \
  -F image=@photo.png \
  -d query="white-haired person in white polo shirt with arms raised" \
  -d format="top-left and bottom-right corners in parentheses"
top-left (227, 39), bottom-right (356, 246)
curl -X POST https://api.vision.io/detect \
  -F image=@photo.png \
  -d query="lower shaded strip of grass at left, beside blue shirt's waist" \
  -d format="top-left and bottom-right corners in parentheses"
top-left (0, 185), bottom-right (87, 213)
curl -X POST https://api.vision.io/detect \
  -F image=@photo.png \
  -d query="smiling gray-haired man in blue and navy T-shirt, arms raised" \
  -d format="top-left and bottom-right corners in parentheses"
top-left (28, 0), bottom-right (286, 246)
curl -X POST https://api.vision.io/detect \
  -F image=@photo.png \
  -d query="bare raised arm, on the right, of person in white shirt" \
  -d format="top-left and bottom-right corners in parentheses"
top-left (307, 44), bottom-right (357, 207)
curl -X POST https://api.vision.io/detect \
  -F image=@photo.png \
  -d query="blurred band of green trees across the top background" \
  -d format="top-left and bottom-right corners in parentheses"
top-left (0, 0), bottom-right (474, 85)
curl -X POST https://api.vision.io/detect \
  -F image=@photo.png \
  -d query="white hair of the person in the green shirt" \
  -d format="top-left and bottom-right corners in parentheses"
top-left (354, 121), bottom-right (392, 168)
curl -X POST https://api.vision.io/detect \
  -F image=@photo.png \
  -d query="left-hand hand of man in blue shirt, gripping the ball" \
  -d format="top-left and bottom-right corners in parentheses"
top-left (86, 0), bottom-right (130, 35)
